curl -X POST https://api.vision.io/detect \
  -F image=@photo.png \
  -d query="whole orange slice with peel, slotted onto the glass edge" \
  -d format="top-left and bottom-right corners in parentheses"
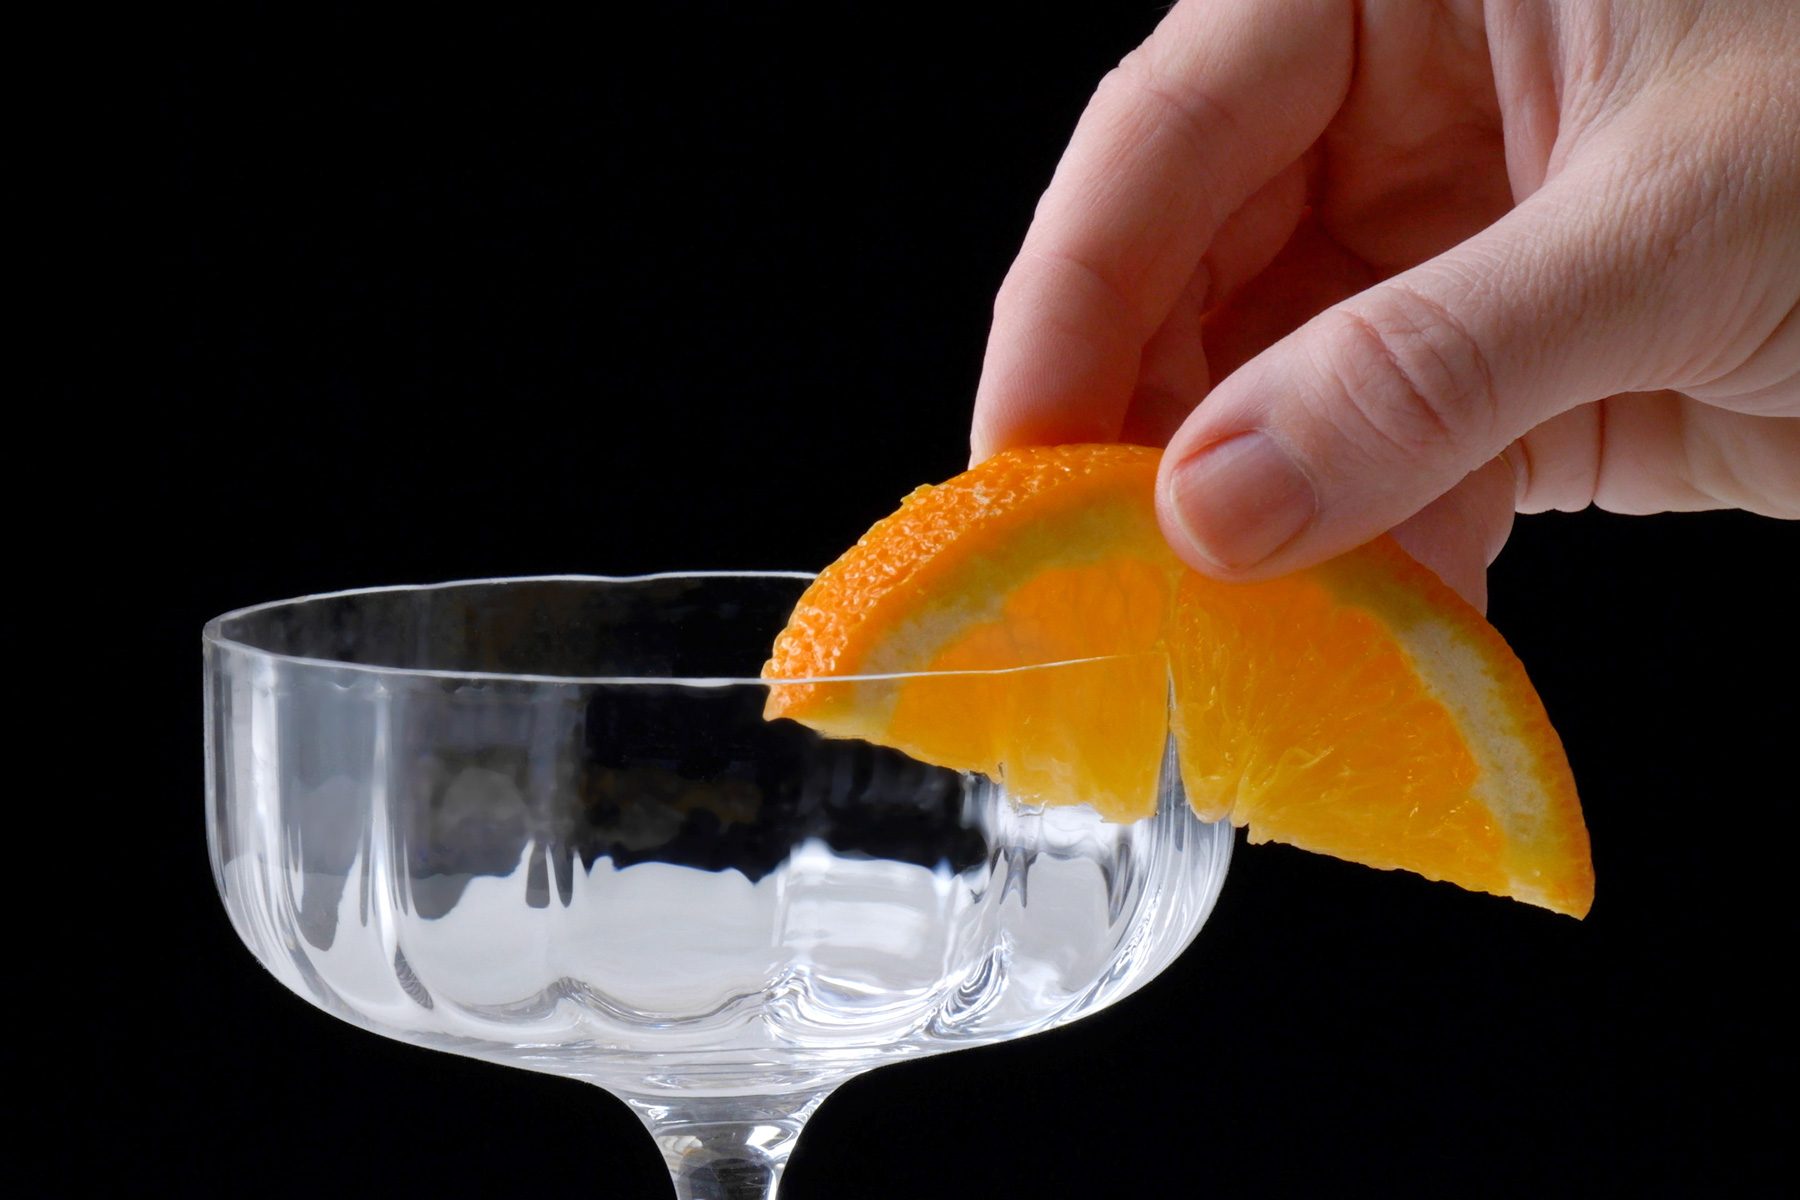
top-left (763, 446), bottom-right (1593, 916)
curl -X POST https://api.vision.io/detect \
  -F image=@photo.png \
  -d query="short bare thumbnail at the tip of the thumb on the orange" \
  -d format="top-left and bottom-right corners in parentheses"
top-left (1170, 430), bottom-right (1319, 570)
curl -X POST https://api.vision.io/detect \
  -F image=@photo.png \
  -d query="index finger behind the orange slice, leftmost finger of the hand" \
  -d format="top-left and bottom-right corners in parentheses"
top-left (970, 0), bottom-right (1354, 459)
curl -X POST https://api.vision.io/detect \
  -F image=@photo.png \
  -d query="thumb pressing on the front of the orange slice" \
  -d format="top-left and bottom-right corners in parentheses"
top-left (1157, 134), bottom-right (1732, 579)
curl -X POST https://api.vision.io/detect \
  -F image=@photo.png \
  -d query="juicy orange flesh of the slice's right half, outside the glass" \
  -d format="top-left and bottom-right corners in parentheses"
top-left (1174, 564), bottom-right (1507, 892)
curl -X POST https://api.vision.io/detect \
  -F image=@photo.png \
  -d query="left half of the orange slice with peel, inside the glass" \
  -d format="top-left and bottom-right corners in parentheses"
top-left (763, 446), bottom-right (1175, 820)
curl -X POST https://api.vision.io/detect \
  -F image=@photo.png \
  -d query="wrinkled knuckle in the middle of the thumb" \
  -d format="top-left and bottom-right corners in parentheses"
top-left (1321, 291), bottom-right (1498, 457)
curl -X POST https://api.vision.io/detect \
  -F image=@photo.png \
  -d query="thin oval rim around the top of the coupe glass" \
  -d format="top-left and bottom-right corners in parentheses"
top-left (200, 570), bottom-right (1141, 687)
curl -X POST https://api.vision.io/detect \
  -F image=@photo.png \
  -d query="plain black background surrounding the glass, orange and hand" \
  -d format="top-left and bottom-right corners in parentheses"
top-left (31, 4), bottom-right (1800, 1200)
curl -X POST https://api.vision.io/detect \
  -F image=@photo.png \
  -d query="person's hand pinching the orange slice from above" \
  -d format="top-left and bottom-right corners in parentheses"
top-left (970, 0), bottom-right (1800, 606)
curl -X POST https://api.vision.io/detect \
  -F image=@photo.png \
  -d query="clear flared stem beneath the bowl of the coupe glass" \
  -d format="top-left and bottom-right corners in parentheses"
top-left (625, 1088), bottom-right (830, 1200)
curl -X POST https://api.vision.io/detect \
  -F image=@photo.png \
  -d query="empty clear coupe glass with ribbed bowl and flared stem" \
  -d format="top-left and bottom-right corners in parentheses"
top-left (203, 574), bottom-right (1231, 1198)
